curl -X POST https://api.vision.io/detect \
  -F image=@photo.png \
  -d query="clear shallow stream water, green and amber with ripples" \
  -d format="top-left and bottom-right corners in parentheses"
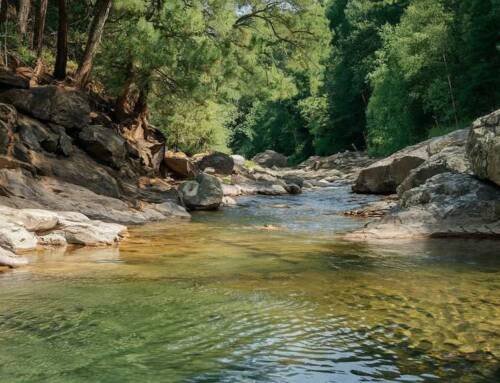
top-left (0, 188), bottom-right (500, 383)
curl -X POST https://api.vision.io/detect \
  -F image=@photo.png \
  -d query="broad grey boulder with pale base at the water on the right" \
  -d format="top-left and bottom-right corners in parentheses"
top-left (346, 173), bottom-right (500, 240)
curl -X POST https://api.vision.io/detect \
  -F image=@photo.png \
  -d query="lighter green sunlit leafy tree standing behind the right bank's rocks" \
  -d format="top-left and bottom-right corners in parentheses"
top-left (367, 0), bottom-right (458, 154)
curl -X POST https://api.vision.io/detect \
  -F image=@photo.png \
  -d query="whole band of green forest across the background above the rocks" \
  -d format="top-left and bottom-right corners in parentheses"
top-left (0, 0), bottom-right (500, 163)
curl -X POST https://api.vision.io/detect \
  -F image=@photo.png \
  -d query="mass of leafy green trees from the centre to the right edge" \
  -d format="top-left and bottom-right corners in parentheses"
top-left (235, 0), bottom-right (500, 158)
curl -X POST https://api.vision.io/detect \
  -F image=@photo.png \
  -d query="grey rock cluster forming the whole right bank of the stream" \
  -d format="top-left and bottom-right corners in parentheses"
top-left (347, 110), bottom-right (500, 239)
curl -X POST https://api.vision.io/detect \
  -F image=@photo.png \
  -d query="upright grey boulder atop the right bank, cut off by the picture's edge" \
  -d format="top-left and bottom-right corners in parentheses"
top-left (467, 109), bottom-right (500, 185)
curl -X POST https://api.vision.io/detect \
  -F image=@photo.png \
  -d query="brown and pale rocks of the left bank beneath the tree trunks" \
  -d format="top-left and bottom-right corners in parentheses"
top-left (0, 70), bottom-right (190, 266)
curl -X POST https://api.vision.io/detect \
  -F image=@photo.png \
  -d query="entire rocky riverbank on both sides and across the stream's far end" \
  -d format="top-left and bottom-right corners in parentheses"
top-left (0, 67), bottom-right (500, 267)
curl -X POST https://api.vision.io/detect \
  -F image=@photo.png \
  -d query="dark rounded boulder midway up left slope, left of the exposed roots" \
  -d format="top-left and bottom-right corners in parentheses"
top-left (78, 125), bottom-right (127, 169)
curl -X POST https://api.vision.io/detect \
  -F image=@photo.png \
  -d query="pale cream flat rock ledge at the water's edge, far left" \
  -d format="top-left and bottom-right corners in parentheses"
top-left (0, 206), bottom-right (127, 267)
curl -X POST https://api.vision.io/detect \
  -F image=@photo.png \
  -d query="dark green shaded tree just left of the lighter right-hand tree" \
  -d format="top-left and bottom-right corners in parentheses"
top-left (315, 0), bottom-right (409, 155)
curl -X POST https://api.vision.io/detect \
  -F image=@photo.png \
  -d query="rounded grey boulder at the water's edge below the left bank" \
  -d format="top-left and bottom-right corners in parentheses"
top-left (179, 173), bottom-right (224, 210)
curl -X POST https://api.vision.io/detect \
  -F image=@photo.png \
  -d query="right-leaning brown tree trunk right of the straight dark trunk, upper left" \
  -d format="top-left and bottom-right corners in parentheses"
top-left (76, 0), bottom-right (112, 86)
